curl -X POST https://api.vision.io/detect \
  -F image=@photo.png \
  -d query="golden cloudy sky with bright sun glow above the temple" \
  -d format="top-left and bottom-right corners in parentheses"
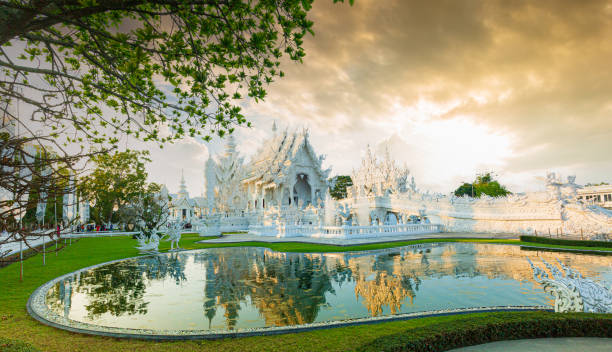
top-left (143, 0), bottom-right (612, 196)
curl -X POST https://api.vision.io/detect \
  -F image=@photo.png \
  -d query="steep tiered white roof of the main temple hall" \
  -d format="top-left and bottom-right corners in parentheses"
top-left (243, 129), bottom-right (331, 184)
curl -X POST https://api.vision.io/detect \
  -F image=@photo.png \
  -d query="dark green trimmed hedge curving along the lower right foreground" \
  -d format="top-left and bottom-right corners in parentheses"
top-left (358, 312), bottom-right (612, 352)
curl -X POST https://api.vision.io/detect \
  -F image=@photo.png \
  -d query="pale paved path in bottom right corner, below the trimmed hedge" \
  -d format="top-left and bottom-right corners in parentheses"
top-left (451, 337), bottom-right (612, 352)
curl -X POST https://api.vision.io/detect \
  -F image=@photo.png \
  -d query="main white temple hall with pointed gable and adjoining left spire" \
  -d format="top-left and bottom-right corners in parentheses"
top-left (198, 128), bottom-right (330, 231)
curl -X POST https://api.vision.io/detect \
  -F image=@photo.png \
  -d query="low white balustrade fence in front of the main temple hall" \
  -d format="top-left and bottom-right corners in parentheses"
top-left (249, 224), bottom-right (443, 239)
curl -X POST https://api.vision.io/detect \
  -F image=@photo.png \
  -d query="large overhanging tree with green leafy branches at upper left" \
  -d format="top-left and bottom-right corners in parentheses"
top-left (0, 0), bottom-right (353, 264)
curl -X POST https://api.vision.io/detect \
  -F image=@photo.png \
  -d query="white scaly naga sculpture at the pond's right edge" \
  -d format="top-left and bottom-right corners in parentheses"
top-left (527, 258), bottom-right (612, 313)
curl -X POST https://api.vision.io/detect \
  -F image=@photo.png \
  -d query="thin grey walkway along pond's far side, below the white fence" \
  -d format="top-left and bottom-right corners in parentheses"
top-left (198, 232), bottom-right (518, 246)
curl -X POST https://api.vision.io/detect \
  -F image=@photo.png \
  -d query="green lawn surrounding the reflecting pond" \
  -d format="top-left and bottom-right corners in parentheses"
top-left (0, 234), bottom-right (612, 352)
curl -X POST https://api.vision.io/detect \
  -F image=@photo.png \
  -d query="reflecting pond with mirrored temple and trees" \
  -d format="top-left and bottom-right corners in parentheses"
top-left (46, 243), bottom-right (612, 331)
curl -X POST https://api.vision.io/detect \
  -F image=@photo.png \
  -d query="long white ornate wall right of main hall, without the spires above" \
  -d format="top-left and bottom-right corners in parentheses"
top-left (345, 192), bottom-right (612, 238)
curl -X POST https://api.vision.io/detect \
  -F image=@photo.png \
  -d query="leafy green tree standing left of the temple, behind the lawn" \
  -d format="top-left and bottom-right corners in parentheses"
top-left (79, 150), bottom-right (149, 224)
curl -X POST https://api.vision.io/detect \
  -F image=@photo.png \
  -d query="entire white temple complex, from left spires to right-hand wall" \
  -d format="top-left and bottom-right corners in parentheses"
top-left (164, 126), bottom-right (612, 242)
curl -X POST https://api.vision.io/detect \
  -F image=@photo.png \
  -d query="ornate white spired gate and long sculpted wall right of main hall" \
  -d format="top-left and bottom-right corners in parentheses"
top-left (340, 150), bottom-right (612, 239)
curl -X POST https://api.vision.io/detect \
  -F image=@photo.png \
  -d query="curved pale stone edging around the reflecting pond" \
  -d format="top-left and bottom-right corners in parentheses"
top-left (26, 243), bottom-right (554, 341)
